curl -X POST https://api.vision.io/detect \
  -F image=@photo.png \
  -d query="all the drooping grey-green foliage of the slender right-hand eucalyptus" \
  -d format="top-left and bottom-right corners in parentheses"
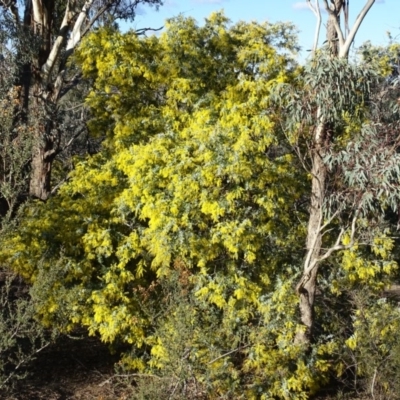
top-left (275, 52), bottom-right (400, 225)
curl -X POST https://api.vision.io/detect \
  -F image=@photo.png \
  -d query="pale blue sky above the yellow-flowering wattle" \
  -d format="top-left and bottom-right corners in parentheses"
top-left (132, 0), bottom-right (400, 58)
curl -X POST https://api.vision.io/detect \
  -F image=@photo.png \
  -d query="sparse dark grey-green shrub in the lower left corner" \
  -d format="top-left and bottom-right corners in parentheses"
top-left (0, 273), bottom-right (50, 392)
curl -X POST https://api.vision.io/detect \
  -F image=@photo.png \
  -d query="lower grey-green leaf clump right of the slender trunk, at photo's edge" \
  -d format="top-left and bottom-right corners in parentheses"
top-left (325, 122), bottom-right (400, 216)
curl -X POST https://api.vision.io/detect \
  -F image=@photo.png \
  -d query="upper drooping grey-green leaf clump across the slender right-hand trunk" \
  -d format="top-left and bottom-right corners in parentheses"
top-left (274, 51), bottom-right (377, 131)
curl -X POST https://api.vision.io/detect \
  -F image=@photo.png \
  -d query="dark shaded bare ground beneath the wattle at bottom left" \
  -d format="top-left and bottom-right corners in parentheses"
top-left (4, 338), bottom-right (127, 400)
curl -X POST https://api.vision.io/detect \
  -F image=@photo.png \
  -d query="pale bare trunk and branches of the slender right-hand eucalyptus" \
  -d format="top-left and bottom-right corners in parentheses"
top-left (295, 0), bottom-right (375, 345)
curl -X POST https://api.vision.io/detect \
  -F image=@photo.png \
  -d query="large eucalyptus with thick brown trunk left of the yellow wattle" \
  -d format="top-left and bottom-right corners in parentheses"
top-left (0, 0), bottom-right (162, 200)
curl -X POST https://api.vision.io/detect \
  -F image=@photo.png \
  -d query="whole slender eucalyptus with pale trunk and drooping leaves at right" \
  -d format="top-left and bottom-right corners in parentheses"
top-left (287, 0), bottom-right (400, 344)
